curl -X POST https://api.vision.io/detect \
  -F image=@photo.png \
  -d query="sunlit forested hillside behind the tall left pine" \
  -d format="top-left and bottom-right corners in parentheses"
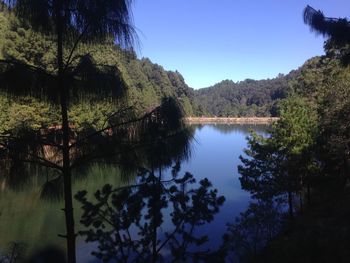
top-left (0, 10), bottom-right (197, 132)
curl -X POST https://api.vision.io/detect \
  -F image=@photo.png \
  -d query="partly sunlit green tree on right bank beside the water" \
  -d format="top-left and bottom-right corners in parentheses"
top-left (238, 96), bottom-right (317, 216)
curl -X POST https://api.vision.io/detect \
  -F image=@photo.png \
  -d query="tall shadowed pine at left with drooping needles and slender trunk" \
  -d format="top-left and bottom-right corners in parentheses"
top-left (1, 0), bottom-right (139, 262)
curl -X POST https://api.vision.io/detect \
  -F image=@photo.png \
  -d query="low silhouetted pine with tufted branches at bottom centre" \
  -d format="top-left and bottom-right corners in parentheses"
top-left (76, 164), bottom-right (225, 262)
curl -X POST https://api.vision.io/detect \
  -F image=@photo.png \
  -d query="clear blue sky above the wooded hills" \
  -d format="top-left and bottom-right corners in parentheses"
top-left (133, 0), bottom-right (350, 89)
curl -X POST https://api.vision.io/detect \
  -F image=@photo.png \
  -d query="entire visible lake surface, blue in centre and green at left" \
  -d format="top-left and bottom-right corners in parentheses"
top-left (0, 124), bottom-right (267, 262)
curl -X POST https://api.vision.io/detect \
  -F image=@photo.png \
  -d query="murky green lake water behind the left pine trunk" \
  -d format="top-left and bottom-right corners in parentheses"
top-left (0, 164), bottom-right (126, 254)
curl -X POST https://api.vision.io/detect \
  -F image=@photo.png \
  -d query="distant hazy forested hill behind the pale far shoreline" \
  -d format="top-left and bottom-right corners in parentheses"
top-left (195, 71), bottom-right (298, 117)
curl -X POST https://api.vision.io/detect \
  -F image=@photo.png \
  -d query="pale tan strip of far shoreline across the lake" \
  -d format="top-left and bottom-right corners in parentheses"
top-left (185, 117), bottom-right (279, 124)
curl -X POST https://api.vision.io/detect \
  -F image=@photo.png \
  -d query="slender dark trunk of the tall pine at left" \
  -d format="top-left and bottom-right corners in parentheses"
top-left (57, 5), bottom-right (76, 263)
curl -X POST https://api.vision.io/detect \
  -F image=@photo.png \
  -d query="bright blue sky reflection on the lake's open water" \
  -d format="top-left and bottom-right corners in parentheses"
top-left (77, 124), bottom-right (267, 262)
